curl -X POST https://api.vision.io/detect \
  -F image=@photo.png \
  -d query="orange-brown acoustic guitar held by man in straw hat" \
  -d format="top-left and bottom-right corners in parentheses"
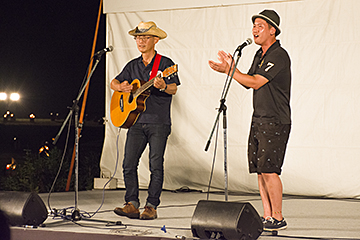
top-left (110, 64), bottom-right (177, 128)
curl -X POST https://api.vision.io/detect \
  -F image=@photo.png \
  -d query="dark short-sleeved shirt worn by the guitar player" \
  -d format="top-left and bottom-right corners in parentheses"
top-left (115, 53), bottom-right (180, 125)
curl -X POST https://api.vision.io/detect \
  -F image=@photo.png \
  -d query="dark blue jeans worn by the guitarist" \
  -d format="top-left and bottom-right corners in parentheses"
top-left (123, 123), bottom-right (171, 208)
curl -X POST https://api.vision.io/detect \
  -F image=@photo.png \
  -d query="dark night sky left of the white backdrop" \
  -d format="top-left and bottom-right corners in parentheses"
top-left (0, 0), bottom-right (106, 118)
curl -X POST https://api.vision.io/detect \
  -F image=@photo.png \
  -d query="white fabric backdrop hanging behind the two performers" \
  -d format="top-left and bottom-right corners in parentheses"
top-left (100, 0), bottom-right (360, 198)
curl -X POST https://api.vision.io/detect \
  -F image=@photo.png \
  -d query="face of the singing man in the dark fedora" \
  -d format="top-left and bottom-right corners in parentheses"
top-left (252, 18), bottom-right (276, 45)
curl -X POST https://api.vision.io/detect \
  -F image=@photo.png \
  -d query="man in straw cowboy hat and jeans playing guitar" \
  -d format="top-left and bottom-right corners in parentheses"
top-left (110, 22), bottom-right (180, 219)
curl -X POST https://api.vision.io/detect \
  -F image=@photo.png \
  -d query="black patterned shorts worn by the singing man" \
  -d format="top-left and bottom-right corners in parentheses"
top-left (248, 122), bottom-right (291, 175)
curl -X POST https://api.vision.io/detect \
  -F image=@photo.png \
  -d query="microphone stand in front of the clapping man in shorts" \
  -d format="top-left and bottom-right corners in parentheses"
top-left (205, 48), bottom-right (245, 201)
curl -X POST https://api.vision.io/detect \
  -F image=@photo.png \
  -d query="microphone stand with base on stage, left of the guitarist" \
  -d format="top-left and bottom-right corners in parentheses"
top-left (53, 52), bottom-right (121, 225)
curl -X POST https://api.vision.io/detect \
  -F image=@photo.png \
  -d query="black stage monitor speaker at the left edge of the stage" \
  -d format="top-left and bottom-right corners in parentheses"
top-left (0, 192), bottom-right (48, 226)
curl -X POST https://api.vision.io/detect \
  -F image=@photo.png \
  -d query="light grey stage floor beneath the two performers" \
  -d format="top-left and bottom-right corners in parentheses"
top-left (11, 190), bottom-right (360, 240)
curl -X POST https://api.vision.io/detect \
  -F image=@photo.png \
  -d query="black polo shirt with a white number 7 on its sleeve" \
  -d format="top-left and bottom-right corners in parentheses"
top-left (248, 40), bottom-right (291, 124)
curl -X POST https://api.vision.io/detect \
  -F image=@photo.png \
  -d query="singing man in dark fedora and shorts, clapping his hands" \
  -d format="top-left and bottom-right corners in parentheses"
top-left (209, 10), bottom-right (291, 231)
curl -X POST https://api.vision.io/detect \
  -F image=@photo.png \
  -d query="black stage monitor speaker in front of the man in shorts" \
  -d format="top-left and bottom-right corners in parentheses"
top-left (191, 200), bottom-right (263, 240)
